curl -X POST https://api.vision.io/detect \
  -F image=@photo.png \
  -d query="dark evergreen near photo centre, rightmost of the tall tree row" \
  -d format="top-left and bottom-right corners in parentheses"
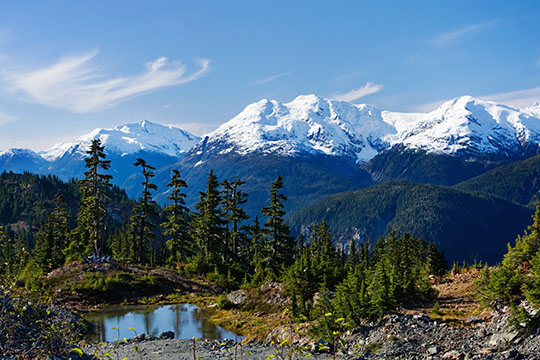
top-left (262, 176), bottom-right (294, 274)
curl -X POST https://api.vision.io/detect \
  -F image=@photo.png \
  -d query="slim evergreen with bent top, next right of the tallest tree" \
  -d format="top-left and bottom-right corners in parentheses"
top-left (130, 158), bottom-right (157, 263)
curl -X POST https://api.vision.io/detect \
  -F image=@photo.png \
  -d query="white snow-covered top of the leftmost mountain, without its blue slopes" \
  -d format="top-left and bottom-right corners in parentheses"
top-left (40, 120), bottom-right (200, 161)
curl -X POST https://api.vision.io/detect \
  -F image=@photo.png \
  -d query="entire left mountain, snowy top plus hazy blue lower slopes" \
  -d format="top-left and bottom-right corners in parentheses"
top-left (0, 120), bottom-right (200, 197)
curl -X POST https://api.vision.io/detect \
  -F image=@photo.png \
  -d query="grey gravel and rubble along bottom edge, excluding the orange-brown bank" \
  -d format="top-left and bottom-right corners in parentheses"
top-left (84, 314), bottom-right (540, 360)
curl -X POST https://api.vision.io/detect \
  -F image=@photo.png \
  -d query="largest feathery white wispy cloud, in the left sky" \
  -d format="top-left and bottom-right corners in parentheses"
top-left (4, 51), bottom-right (210, 113)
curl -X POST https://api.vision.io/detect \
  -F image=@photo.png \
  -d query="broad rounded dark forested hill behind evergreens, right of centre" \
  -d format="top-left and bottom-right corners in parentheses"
top-left (289, 181), bottom-right (532, 264)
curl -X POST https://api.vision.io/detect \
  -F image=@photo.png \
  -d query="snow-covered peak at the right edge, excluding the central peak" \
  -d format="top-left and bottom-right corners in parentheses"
top-left (383, 96), bottom-right (540, 156)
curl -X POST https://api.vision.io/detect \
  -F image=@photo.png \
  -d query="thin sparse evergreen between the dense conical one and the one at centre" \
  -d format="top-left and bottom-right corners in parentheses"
top-left (221, 177), bottom-right (249, 258)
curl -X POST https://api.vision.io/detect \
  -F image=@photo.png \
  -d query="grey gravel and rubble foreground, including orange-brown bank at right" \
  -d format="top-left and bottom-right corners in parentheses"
top-left (81, 269), bottom-right (540, 360)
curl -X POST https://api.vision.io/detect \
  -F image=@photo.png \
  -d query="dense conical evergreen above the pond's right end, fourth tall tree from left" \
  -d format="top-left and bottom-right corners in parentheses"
top-left (191, 170), bottom-right (225, 271)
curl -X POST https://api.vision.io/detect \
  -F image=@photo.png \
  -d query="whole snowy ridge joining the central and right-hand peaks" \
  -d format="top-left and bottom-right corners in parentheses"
top-left (191, 95), bottom-right (540, 162)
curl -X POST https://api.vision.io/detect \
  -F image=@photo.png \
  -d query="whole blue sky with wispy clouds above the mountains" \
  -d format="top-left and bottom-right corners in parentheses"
top-left (0, 0), bottom-right (540, 150)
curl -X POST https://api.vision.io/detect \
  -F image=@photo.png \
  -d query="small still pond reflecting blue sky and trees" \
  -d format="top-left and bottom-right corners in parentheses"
top-left (86, 304), bottom-right (241, 342)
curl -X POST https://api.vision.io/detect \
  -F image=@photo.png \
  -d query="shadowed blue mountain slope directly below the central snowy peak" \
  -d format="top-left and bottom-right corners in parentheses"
top-left (148, 154), bottom-right (373, 218)
